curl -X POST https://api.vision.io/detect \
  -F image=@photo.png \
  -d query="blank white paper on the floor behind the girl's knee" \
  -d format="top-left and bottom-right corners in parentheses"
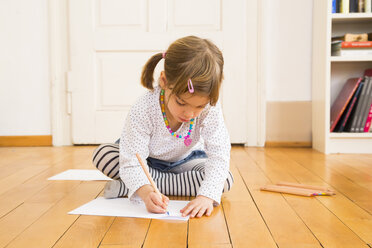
top-left (48, 169), bottom-right (112, 181)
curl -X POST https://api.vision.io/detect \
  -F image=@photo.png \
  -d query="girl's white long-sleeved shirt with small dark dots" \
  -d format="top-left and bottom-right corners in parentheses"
top-left (120, 86), bottom-right (231, 204)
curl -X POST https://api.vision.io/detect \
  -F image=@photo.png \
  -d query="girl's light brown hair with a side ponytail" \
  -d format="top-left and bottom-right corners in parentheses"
top-left (141, 36), bottom-right (224, 106)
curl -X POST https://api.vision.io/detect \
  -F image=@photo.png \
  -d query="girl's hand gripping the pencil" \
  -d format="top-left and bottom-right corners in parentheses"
top-left (137, 185), bottom-right (169, 214)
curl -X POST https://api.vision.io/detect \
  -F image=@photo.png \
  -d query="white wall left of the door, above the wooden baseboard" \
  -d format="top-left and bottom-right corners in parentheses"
top-left (0, 0), bottom-right (51, 136)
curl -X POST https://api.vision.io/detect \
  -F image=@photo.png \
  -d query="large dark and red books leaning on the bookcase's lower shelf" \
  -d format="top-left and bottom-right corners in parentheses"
top-left (330, 69), bottom-right (372, 133)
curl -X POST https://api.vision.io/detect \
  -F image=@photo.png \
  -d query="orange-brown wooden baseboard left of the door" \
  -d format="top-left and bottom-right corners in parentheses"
top-left (0, 135), bottom-right (52, 146)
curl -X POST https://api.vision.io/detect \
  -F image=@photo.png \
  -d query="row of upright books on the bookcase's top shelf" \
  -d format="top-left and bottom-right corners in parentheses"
top-left (332, 0), bottom-right (372, 13)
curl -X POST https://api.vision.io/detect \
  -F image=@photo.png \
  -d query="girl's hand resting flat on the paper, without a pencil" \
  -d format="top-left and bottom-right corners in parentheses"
top-left (180, 195), bottom-right (213, 218)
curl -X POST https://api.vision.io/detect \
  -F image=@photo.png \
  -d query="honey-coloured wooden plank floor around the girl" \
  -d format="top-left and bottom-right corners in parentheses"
top-left (0, 146), bottom-right (372, 248)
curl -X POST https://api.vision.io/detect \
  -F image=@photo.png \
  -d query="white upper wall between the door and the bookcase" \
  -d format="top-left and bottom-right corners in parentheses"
top-left (262, 0), bottom-right (313, 101)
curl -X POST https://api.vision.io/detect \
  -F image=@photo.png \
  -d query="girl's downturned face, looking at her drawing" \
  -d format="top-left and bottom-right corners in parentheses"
top-left (160, 73), bottom-right (209, 122)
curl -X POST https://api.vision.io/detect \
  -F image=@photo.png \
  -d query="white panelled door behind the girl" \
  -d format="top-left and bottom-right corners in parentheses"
top-left (68, 0), bottom-right (257, 144)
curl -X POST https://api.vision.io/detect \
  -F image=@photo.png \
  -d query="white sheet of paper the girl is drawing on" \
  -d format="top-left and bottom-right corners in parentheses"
top-left (69, 197), bottom-right (189, 221)
